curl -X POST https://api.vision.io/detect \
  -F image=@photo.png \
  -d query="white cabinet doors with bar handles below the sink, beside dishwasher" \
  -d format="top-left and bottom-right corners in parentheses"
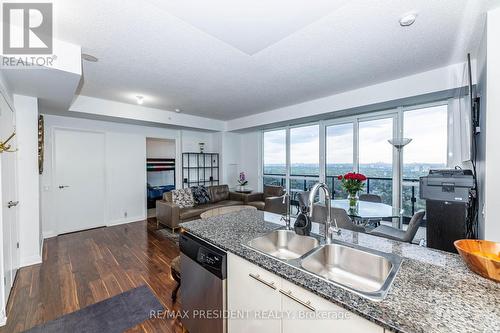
top-left (227, 254), bottom-right (384, 333)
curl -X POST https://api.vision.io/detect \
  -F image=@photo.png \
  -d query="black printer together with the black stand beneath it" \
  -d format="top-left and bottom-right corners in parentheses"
top-left (420, 169), bottom-right (474, 253)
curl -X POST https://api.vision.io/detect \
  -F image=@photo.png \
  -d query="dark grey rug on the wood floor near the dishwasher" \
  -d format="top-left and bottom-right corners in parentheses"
top-left (26, 286), bottom-right (164, 333)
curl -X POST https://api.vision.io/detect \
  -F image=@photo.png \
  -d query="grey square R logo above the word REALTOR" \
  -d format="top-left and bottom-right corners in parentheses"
top-left (3, 3), bottom-right (53, 54)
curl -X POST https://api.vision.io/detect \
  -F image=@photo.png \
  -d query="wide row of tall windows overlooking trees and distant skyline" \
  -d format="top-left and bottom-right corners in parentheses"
top-left (263, 102), bottom-right (448, 217)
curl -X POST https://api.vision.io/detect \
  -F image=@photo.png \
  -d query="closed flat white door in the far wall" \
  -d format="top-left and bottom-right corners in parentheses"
top-left (53, 129), bottom-right (105, 234)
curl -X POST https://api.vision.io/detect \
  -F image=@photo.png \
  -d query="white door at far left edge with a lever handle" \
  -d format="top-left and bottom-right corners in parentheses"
top-left (0, 97), bottom-right (19, 302)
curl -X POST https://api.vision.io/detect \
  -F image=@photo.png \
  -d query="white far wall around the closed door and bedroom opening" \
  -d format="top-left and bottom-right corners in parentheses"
top-left (41, 115), bottom-right (214, 238)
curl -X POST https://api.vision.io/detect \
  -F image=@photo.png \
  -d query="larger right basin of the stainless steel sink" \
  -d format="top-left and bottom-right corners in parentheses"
top-left (301, 243), bottom-right (401, 300)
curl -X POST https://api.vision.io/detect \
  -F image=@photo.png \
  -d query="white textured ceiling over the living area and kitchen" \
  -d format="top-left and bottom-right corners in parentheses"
top-left (54, 0), bottom-right (499, 120)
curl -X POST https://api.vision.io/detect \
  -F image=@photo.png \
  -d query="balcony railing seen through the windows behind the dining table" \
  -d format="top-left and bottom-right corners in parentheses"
top-left (264, 174), bottom-right (425, 218)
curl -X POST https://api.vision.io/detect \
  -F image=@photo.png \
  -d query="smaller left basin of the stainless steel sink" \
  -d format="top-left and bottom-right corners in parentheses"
top-left (247, 230), bottom-right (319, 260)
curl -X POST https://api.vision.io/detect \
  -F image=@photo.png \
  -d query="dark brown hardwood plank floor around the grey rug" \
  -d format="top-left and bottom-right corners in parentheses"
top-left (0, 219), bottom-right (183, 333)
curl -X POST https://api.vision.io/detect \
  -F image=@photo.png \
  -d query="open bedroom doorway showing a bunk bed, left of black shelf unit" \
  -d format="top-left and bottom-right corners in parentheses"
top-left (146, 138), bottom-right (176, 217)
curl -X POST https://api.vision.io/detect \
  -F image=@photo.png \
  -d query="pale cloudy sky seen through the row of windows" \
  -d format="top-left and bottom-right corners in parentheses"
top-left (264, 105), bottom-right (448, 164)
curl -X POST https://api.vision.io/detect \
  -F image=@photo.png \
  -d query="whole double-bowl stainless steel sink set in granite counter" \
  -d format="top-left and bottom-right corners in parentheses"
top-left (246, 230), bottom-right (401, 300)
